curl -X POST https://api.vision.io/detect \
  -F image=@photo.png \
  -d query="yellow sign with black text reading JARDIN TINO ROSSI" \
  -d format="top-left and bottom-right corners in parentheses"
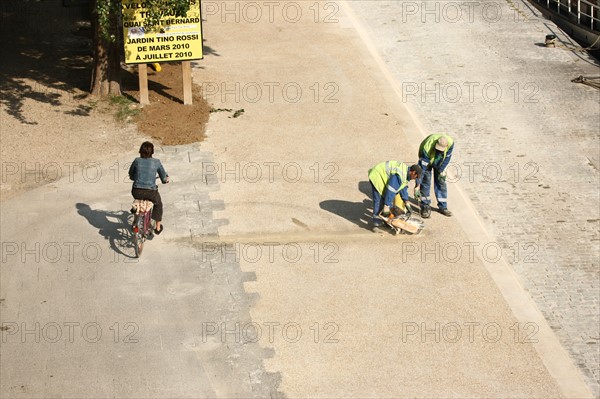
top-left (121, 0), bottom-right (203, 64)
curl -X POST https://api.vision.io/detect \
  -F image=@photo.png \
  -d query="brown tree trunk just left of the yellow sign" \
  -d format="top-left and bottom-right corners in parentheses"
top-left (90, 0), bottom-right (121, 97)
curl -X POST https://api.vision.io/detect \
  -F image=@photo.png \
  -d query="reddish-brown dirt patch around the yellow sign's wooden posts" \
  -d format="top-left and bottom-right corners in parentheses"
top-left (123, 62), bottom-right (210, 145)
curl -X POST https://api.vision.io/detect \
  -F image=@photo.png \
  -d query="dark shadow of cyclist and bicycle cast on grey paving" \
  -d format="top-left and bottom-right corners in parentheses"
top-left (75, 203), bottom-right (135, 258)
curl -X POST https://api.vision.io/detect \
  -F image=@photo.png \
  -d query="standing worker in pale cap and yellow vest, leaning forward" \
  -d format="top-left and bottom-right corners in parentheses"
top-left (415, 134), bottom-right (454, 218)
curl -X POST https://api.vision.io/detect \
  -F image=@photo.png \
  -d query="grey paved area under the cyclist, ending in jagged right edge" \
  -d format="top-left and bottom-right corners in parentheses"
top-left (0, 144), bottom-right (280, 398)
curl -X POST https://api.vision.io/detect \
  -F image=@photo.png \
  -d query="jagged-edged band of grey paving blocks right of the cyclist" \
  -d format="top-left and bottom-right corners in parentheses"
top-left (157, 143), bottom-right (281, 398)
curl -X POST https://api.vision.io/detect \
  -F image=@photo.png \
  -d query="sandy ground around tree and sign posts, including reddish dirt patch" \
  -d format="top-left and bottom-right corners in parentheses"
top-left (0, 29), bottom-right (209, 201)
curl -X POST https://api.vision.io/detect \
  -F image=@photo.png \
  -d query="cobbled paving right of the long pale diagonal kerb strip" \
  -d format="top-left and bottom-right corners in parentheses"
top-left (349, 1), bottom-right (600, 395)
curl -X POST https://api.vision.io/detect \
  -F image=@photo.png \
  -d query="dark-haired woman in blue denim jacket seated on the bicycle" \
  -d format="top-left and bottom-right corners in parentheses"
top-left (129, 141), bottom-right (169, 234)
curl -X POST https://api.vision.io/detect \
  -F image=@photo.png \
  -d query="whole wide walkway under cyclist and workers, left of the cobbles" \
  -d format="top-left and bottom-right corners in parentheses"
top-left (0, 2), bottom-right (597, 397)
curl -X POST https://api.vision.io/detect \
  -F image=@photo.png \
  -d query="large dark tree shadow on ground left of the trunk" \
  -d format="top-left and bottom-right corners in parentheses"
top-left (0, 1), bottom-right (91, 125)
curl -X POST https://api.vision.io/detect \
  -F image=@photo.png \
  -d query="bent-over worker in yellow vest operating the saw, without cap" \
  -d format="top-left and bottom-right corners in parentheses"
top-left (369, 161), bottom-right (421, 227)
